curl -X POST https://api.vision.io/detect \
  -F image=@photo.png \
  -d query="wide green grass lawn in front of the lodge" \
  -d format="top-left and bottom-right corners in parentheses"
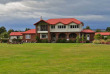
top-left (0, 44), bottom-right (110, 74)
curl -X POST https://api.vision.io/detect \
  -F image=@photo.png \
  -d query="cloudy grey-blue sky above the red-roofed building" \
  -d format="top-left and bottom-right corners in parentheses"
top-left (0, 0), bottom-right (110, 30)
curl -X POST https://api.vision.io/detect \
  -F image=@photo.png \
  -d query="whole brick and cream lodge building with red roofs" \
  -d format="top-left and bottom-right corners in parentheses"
top-left (10, 18), bottom-right (95, 42)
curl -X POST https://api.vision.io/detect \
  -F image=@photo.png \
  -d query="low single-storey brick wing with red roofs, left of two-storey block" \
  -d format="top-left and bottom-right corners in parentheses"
top-left (9, 29), bottom-right (36, 42)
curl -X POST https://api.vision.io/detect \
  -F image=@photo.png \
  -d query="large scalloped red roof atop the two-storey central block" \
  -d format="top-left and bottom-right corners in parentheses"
top-left (34, 18), bottom-right (82, 25)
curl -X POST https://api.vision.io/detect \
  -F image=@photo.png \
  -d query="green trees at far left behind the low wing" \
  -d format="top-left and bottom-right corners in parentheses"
top-left (0, 26), bottom-right (30, 39)
